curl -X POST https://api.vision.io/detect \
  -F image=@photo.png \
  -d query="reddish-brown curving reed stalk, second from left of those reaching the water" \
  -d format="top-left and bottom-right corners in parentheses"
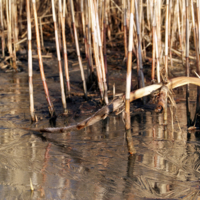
top-left (32, 0), bottom-right (55, 117)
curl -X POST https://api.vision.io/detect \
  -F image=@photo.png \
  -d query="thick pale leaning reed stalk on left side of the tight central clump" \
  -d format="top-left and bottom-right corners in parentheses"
top-left (88, 0), bottom-right (104, 99)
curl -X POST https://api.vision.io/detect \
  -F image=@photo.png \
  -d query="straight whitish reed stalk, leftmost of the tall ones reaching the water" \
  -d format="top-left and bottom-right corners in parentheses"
top-left (26, 0), bottom-right (37, 122)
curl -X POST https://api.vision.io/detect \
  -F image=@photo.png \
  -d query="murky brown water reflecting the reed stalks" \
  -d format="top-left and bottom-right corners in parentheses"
top-left (0, 62), bottom-right (200, 200)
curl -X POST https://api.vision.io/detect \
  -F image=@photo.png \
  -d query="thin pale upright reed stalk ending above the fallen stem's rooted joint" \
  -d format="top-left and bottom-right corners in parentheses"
top-left (165, 0), bottom-right (169, 78)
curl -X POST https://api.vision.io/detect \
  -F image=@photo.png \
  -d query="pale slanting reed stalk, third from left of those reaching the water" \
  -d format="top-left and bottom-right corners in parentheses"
top-left (51, 0), bottom-right (67, 113)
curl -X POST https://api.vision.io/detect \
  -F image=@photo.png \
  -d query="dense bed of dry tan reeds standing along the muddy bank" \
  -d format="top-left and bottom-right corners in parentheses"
top-left (0, 0), bottom-right (200, 130)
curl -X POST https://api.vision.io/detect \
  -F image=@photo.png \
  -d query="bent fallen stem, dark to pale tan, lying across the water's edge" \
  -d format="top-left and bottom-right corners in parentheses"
top-left (23, 77), bottom-right (200, 133)
